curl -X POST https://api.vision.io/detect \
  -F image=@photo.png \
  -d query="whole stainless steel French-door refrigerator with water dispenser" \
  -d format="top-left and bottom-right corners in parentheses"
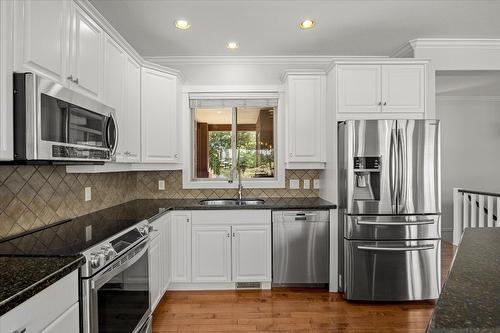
top-left (338, 120), bottom-right (441, 301)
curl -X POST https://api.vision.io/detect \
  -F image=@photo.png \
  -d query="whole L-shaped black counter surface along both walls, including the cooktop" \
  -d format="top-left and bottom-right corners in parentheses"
top-left (0, 198), bottom-right (337, 315)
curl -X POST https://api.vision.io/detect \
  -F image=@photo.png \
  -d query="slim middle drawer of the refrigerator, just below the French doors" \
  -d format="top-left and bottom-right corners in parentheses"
top-left (344, 215), bottom-right (441, 240)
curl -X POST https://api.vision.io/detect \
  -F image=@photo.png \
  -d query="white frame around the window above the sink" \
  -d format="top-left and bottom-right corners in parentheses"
top-left (182, 86), bottom-right (285, 189)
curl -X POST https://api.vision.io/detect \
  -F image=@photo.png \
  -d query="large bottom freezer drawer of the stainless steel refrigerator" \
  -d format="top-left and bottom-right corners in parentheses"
top-left (344, 240), bottom-right (441, 301)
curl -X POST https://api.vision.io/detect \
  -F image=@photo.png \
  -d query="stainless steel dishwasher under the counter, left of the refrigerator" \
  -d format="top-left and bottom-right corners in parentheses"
top-left (273, 210), bottom-right (330, 286)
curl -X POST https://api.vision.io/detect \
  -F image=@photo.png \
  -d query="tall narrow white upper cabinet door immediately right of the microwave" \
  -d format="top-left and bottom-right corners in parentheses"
top-left (103, 35), bottom-right (127, 162)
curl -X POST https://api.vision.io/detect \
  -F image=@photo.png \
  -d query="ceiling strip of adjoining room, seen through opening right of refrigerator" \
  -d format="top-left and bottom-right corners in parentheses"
top-left (436, 71), bottom-right (500, 97)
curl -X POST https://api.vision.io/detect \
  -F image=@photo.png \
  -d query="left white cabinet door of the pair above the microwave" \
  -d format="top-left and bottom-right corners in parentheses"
top-left (14, 0), bottom-right (71, 85)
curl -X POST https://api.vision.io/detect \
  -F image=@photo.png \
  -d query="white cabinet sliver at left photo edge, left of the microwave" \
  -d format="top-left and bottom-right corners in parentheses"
top-left (0, 0), bottom-right (14, 160)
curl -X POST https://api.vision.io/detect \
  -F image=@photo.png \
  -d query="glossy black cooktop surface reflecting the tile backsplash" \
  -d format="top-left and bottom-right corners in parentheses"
top-left (0, 202), bottom-right (158, 256)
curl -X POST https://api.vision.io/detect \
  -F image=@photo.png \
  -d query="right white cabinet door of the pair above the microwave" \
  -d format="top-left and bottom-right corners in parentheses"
top-left (69, 5), bottom-right (104, 99)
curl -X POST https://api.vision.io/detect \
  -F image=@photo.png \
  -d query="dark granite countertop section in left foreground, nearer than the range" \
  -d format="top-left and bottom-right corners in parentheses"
top-left (0, 255), bottom-right (85, 316)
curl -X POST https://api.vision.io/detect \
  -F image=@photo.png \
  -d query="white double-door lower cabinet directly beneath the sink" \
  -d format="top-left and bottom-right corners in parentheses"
top-left (191, 211), bottom-right (271, 283)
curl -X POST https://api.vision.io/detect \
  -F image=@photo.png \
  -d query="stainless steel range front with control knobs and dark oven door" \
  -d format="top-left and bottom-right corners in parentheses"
top-left (81, 221), bottom-right (151, 333)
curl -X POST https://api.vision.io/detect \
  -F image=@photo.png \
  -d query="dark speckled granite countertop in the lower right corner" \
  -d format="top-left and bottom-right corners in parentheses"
top-left (428, 228), bottom-right (500, 333)
